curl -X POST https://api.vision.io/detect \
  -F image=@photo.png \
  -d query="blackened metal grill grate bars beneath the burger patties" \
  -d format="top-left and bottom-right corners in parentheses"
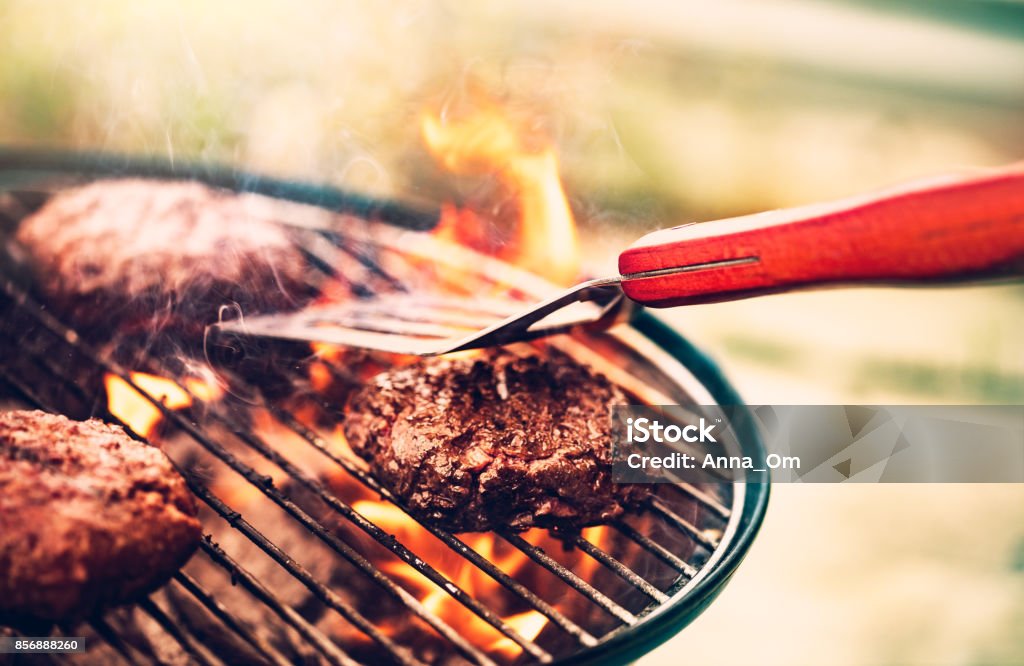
top-left (0, 177), bottom-right (753, 664)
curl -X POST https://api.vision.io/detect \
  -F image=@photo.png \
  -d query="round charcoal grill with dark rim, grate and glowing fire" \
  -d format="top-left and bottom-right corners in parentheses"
top-left (0, 152), bottom-right (769, 664)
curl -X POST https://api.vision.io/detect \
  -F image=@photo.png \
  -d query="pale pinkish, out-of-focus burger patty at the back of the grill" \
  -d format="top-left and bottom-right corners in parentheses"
top-left (16, 179), bottom-right (313, 336)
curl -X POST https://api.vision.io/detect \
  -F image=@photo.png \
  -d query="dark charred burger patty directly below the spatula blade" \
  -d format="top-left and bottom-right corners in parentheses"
top-left (345, 350), bottom-right (649, 532)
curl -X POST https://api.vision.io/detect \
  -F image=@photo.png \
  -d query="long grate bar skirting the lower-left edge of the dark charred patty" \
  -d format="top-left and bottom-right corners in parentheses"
top-left (271, 408), bottom-right (597, 647)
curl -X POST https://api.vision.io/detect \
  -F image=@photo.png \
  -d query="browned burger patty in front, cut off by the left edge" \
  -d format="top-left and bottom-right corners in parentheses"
top-left (0, 411), bottom-right (201, 624)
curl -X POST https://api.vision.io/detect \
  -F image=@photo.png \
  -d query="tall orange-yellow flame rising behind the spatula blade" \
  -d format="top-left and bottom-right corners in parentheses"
top-left (421, 103), bottom-right (580, 285)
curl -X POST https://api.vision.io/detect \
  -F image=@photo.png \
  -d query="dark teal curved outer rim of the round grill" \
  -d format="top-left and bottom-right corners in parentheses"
top-left (0, 147), bottom-right (770, 664)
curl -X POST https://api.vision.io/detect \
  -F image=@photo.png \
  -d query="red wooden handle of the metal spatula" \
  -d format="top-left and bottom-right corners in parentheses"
top-left (618, 163), bottom-right (1024, 307)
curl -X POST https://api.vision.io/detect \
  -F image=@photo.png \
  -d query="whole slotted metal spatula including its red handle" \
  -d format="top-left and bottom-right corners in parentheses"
top-left (216, 164), bottom-right (1024, 356)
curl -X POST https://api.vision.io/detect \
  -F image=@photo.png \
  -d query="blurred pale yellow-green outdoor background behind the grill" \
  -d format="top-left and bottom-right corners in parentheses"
top-left (0, 0), bottom-right (1024, 664)
